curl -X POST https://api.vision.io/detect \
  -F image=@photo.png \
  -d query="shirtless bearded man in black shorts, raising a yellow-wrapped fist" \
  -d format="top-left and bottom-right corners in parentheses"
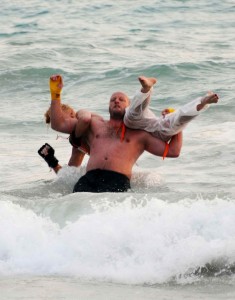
top-left (50, 75), bottom-right (182, 192)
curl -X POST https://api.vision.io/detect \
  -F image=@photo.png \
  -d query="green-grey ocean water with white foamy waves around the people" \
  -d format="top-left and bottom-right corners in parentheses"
top-left (0, 0), bottom-right (235, 300)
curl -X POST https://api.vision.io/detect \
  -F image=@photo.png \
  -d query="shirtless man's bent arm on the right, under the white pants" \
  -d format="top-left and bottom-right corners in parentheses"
top-left (144, 132), bottom-right (183, 157)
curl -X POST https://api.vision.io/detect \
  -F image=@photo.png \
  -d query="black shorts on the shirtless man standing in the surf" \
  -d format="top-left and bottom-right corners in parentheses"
top-left (73, 169), bottom-right (130, 193)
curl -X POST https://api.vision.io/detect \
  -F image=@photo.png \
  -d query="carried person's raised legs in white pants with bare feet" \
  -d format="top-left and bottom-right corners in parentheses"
top-left (124, 76), bottom-right (219, 142)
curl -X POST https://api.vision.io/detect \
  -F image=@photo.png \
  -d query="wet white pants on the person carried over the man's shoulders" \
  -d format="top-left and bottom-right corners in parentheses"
top-left (124, 89), bottom-right (208, 141)
